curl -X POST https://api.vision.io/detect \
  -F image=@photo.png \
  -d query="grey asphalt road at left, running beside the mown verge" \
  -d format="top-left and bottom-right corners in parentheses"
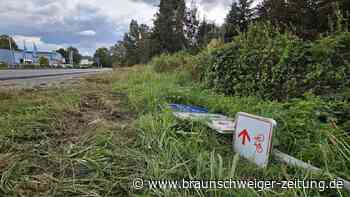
top-left (0, 69), bottom-right (112, 88)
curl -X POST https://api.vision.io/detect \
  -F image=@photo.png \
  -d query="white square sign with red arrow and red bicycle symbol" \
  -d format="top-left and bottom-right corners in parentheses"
top-left (233, 112), bottom-right (277, 167)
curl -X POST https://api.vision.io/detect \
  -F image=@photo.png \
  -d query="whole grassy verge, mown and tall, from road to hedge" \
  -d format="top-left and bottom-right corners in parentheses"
top-left (0, 67), bottom-right (350, 196)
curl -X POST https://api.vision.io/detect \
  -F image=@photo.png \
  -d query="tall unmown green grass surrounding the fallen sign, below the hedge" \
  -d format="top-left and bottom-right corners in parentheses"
top-left (114, 67), bottom-right (350, 196)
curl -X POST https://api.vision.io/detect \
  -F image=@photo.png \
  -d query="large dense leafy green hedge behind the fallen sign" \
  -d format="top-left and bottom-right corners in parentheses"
top-left (197, 24), bottom-right (350, 99)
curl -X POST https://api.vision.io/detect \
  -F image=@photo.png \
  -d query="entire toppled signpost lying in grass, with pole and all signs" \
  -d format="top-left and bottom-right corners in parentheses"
top-left (170, 104), bottom-right (350, 191)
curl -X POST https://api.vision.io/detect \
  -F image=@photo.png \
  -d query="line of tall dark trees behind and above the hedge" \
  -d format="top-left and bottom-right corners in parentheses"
top-left (94, 0), bottom-right (350, 67)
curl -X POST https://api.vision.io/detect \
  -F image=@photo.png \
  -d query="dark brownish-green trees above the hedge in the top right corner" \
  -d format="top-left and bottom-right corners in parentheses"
top-left (257, 0), bottom-right (349, 40)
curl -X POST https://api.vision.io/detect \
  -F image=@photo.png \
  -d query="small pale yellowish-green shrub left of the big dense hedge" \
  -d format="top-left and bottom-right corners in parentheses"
top-left (150, 51), bottom-right (194, 72)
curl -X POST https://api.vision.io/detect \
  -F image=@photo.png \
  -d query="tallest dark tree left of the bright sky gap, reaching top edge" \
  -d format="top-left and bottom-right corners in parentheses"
top-left (152, 0), bottom-right (186, 55)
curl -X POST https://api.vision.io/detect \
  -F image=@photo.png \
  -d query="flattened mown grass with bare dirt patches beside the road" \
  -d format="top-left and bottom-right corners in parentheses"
top-left (0, 71), bottom-right (143, 196)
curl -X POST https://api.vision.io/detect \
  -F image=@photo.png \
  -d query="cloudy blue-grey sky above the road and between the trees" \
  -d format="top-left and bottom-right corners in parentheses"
top-left (0, 0), bottom-right (232, 55)
